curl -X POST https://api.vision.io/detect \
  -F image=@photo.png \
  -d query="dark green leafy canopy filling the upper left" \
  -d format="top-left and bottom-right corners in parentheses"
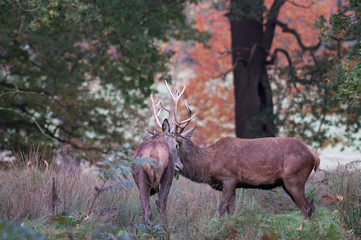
top-left (0, 0), bottom-right (197, 158)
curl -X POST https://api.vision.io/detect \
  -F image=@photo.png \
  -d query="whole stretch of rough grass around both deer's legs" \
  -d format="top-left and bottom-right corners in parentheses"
top-left (0, 153), bottom-right (361, 239)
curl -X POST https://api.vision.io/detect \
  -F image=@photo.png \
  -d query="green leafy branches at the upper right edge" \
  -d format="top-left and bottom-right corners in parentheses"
top-left (315, 0), bottom-right (361, 106)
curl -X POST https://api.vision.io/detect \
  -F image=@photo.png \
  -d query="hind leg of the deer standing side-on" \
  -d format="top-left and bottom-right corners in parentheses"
top-left (283, 178), bottom-right (314, 219)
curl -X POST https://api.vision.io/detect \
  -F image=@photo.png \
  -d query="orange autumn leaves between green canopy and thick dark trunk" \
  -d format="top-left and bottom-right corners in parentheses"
top-left (172, 1), bottom-right (234, 144)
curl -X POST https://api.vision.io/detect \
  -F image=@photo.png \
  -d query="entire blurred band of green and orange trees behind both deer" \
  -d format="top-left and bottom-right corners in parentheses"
top-left (0, 0), bottom-right (361, 157)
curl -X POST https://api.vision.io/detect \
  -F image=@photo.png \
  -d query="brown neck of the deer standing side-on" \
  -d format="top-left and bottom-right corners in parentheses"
top-left (180, 140), bottom-right (212, 182)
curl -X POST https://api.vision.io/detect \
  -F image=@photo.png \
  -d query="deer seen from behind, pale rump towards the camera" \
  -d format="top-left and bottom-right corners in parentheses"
top-left (132, 95), bottom-right (183, 222)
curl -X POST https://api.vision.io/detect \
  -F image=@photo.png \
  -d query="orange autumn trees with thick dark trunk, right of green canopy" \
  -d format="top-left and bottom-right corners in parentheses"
top-left (173, 0), bottom-right (361, 148)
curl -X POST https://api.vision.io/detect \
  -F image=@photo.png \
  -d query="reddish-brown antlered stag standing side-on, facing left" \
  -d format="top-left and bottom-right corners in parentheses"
top-left (162, 82), bottom-right (320, 219)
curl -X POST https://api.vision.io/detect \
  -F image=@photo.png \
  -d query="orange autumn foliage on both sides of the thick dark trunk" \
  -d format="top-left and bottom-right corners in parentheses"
top-left (169, 0), bottom-right (337, 144)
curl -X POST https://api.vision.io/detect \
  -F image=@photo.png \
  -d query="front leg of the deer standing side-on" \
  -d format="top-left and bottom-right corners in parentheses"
top-left (219, 179), bottom-right (237, 217)
